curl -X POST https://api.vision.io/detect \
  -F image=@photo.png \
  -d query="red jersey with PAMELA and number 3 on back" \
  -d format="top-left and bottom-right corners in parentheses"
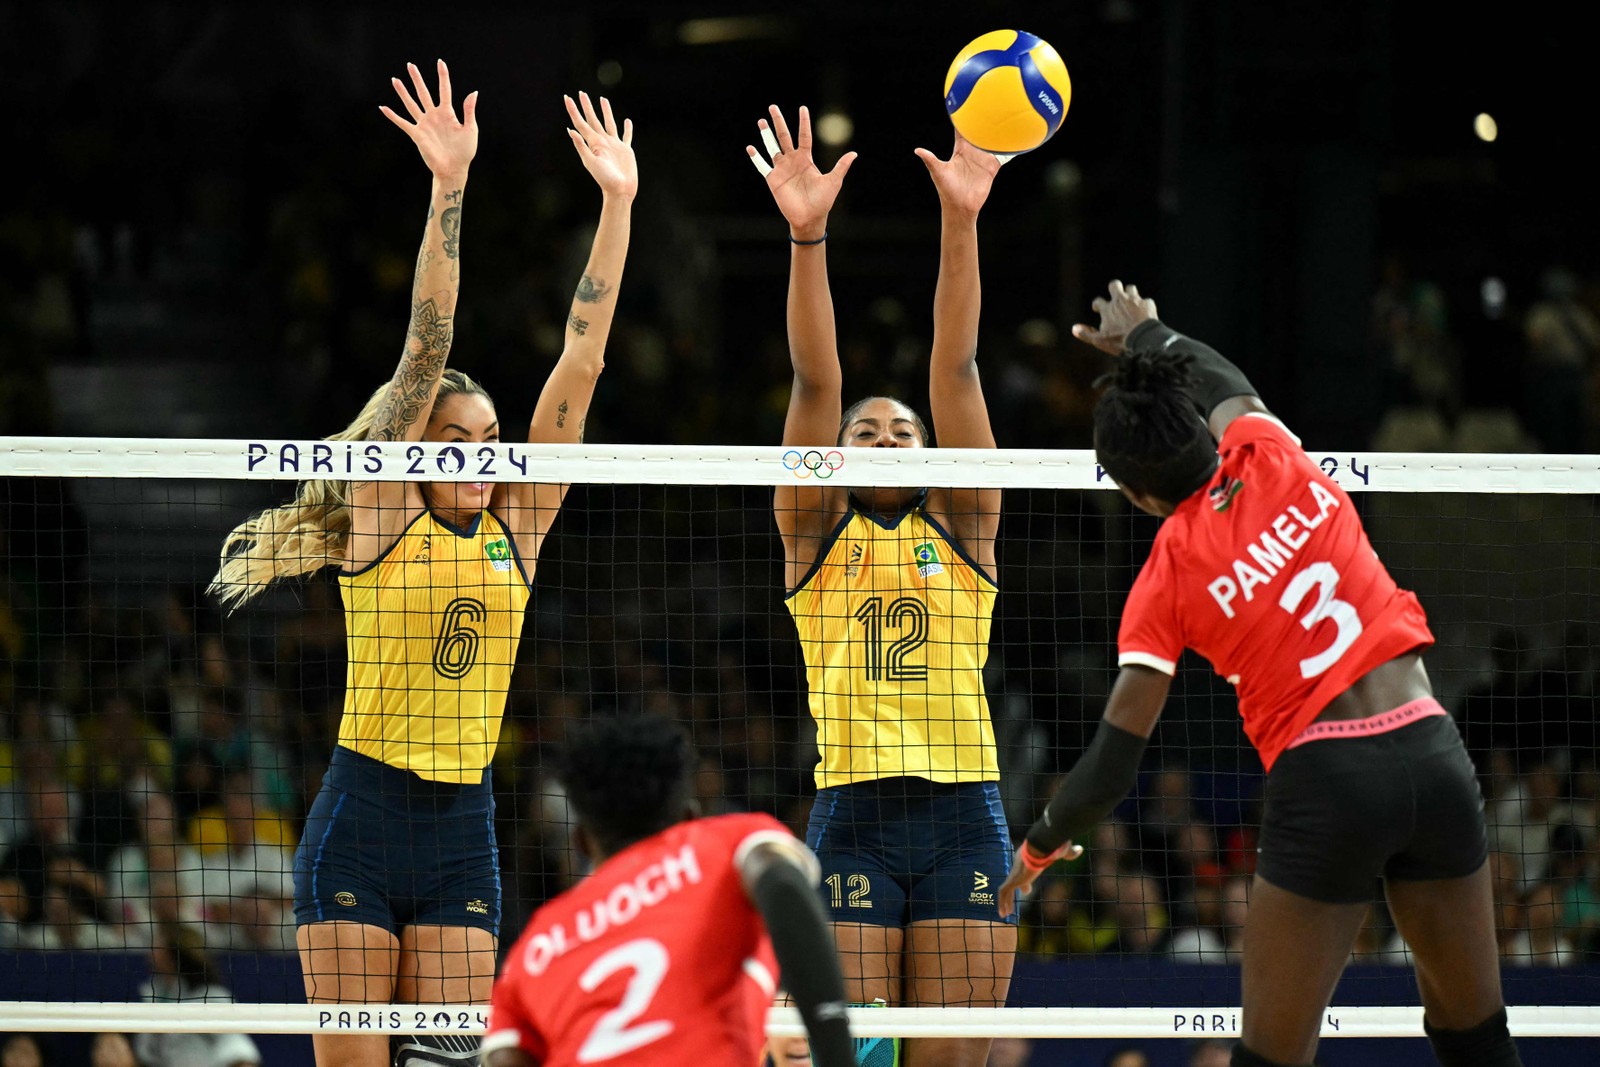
top-left (1117, 414), bottom-right (1434, 769)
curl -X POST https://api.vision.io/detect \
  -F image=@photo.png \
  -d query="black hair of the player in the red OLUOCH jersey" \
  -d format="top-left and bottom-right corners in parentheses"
top-left (555, 715), bottom-right (694, 853)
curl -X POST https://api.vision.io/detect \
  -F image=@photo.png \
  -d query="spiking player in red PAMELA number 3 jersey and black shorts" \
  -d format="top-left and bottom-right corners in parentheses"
top-left (1000, 282), bottom-right (1522, 1067)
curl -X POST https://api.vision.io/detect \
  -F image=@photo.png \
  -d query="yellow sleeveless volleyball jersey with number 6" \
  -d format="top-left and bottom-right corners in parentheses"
top-left (339, 512), bottom-right (530, 784)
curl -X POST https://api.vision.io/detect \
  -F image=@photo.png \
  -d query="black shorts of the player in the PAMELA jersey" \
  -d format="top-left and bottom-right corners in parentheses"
top-left (1256, 715), bottom-right (1488, 904)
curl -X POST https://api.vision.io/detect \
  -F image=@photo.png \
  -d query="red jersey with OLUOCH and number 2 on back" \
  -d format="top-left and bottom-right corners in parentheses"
top-left (483, 814), bottom-right (805, 1067)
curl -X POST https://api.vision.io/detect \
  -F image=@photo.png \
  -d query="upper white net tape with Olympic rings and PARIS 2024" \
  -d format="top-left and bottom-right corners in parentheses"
top-left (0, 437), bottom-right (1600, 493)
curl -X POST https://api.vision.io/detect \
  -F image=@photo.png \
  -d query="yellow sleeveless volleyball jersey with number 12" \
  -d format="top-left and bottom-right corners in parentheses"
top-left (787, 501), bottom-right (1000, 789)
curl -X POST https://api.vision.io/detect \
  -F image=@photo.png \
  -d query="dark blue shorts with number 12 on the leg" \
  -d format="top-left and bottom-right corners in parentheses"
top-left (805, 777), bottom-right (1016, 926)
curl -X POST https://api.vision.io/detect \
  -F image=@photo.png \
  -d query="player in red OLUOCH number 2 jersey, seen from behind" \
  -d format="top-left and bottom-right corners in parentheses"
top-left (483, 718), bottom-right (854, 1067)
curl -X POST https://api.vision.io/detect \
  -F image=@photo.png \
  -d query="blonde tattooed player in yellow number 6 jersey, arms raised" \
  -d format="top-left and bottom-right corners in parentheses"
top-left (213, 62), bottom-right (638, 1067)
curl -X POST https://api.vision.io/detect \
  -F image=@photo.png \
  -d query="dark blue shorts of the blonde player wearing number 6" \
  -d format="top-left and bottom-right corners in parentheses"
top-left (294, 745), bottom-right (501, 936)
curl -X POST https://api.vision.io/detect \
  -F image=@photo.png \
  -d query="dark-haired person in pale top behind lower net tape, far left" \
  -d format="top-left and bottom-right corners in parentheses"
top-left (133, 923), bottom-right (261, 1067)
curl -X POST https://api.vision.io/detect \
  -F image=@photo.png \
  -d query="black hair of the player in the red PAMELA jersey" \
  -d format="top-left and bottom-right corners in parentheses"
top-left (1094, 352), bottom-right (1218, 504)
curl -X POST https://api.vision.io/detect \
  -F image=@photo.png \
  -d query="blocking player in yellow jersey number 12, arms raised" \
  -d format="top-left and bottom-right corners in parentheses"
top-left (747, 107), bottom-right (1016, 1067)
